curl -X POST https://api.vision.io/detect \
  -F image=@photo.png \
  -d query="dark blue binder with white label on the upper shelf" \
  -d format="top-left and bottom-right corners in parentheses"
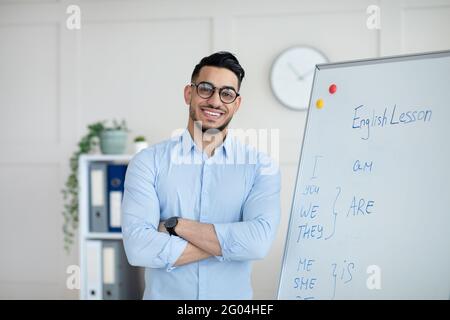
top-left (108, 164), bottom-right (127, 232)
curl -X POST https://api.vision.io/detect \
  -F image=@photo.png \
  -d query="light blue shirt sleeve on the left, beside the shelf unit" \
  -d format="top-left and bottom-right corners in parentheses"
top-left (122, 149), bottom-right (187, 271)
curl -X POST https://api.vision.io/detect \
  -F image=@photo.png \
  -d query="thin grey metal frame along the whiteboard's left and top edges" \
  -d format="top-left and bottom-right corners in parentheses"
top-left (277, 50), bottom-right (450, 300)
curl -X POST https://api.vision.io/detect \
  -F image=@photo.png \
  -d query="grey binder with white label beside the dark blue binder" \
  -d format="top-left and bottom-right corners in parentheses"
top-left (89, 162), bottom-right (108, 232)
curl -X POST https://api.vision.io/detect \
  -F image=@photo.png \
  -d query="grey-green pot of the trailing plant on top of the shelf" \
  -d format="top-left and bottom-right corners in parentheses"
top-left (100, 120), bottom-right (129, 154)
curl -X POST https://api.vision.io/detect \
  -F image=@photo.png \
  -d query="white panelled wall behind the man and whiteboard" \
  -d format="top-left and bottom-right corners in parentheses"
top-left (0, 0), bottom-right (450, 299)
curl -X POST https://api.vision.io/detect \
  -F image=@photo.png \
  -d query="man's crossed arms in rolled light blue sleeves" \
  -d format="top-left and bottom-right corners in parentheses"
top-left (122, 150), bottom-right (280, 271)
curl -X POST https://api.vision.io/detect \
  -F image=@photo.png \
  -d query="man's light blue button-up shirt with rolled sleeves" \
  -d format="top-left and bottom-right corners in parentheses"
top-left (122, 130), bottom-right (280, 299)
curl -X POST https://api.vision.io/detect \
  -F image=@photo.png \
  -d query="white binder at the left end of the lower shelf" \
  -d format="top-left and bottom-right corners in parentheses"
top-left (85, 240), bottom-right (103, 300)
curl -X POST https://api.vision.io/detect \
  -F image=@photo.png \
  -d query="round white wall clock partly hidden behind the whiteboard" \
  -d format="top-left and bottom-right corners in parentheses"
top-left (270, 47), bottom-right (327, 110)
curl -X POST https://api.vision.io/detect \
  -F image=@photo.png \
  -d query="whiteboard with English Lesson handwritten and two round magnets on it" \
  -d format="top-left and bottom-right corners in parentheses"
top-left (278, 51), bottom-right (450, 299)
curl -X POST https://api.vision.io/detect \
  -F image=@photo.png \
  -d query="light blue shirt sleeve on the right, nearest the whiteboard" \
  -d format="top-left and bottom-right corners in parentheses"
top-left (214, 156), bottom-right (281, 261)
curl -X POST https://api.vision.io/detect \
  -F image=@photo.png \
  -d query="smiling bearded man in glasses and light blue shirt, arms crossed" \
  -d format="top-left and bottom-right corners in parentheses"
top-left (122, 52), bottom-right (280, 299)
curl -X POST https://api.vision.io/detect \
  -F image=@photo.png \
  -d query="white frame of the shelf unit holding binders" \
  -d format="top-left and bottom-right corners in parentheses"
top-left (78, 155), bottom-right (133, 300)
